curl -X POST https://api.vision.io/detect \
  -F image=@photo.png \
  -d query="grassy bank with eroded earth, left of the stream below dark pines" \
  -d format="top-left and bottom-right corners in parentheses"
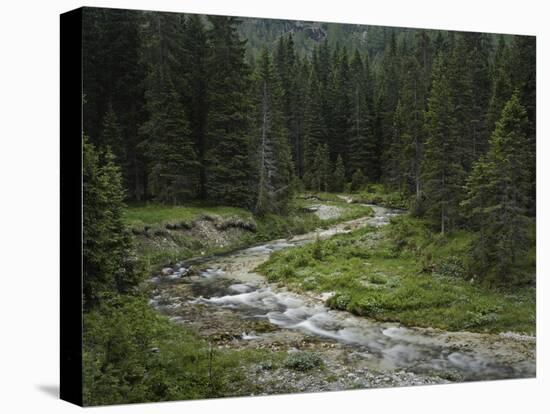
top-left (124, 193), bottom-right (372, 270)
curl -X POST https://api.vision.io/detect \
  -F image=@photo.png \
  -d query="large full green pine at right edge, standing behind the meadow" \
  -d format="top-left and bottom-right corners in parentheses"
top-left (462, 92), bottom-right (530, 282)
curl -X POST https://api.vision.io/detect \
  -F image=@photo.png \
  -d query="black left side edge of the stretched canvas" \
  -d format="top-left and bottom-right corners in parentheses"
top-left (60, 9), bottom-right (82, 405)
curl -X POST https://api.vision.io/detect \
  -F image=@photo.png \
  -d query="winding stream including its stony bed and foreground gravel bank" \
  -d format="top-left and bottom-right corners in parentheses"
top-left (150, 205), bottom-right (536, 393)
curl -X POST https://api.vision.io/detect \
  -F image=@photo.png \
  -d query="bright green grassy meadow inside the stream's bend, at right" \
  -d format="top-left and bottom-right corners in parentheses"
top-left (257, 217), bottom-right (535, 334)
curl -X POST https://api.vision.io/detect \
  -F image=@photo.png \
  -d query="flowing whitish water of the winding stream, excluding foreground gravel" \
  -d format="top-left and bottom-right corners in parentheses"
top-left (151, 206), bottom-right (536, 381)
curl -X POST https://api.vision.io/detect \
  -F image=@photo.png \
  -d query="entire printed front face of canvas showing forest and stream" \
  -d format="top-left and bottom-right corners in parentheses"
top-left (82, 8), bottom-right (536, 405)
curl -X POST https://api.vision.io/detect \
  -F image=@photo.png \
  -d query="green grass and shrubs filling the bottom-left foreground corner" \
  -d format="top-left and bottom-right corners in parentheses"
top-left (83, 296), bottom-right (286, 405)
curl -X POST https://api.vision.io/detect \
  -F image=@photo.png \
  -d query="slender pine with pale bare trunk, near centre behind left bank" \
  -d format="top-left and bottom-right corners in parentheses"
top-left (254, 49), bottom-right (292, 215)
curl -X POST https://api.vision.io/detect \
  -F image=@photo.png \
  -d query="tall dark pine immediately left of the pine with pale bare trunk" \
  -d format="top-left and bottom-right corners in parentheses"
top-left (206, 16), bottom-right (253, 207)
